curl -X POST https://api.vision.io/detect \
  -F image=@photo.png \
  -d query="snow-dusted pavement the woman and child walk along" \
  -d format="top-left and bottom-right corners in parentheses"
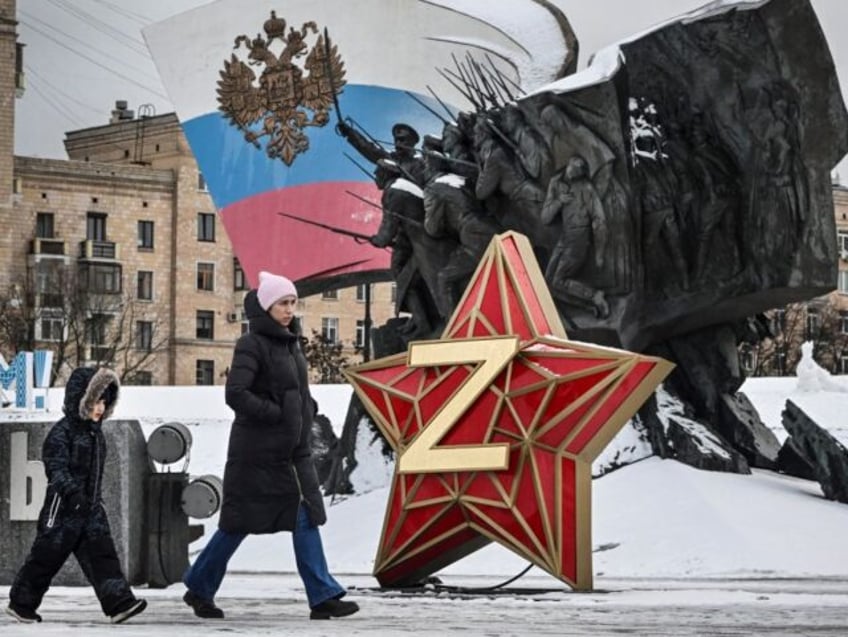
top-left (0, 574), bottom-right (848, 637)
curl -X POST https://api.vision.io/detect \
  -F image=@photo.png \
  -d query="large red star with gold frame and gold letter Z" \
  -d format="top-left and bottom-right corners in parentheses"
top-left (346, 232), bottom-right (672, 589)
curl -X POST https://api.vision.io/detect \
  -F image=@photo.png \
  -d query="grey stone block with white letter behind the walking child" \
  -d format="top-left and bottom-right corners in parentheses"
top-left (0, 419), bottom-right (151, 586)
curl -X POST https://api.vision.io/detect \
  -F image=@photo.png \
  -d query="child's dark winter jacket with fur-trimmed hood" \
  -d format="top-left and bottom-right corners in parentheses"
top-left (41, 367), bottom-right (120, 526)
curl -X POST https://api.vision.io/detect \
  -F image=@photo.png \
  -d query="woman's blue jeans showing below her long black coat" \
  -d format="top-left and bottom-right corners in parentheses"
top-left (183, 507), bottom-right (347, 608)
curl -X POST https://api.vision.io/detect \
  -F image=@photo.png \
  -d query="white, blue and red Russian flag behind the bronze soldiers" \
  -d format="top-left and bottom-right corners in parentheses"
top-left (144, 0), bottom-right (565, 284)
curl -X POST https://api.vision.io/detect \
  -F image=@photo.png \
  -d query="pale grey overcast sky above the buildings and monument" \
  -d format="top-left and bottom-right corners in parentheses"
top-left (15, 0), bottom-right (848, 183)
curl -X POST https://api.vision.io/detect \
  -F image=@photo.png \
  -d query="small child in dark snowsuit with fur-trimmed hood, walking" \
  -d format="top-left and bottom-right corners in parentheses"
top-left (6, 367), bottom-right (147, 624)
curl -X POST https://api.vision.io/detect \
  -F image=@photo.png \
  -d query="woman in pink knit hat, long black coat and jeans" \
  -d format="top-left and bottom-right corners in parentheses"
top-left (183, 272), bottom-right (359, 619)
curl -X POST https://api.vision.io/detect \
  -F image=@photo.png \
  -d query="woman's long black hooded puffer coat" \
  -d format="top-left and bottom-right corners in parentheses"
top-left (218, 290), bottom-right (327, 533)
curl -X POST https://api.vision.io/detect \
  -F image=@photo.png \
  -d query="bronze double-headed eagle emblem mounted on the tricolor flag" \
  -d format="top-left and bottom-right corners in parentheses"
top-left (218, 11), bottom-right (345, 166)
